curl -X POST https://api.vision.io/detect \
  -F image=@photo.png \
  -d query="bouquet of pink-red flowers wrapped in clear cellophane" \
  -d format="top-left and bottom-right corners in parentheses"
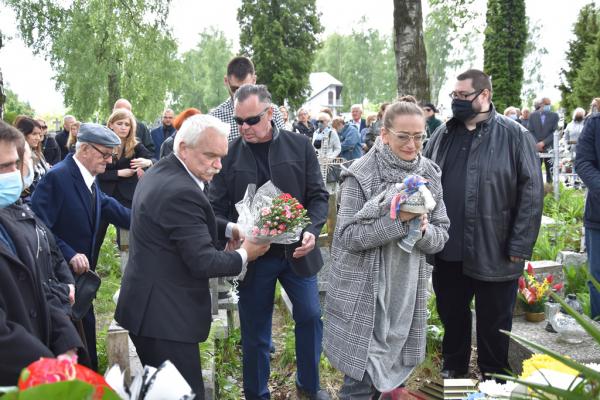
top-left (235, 181), bottom-right (310, 244)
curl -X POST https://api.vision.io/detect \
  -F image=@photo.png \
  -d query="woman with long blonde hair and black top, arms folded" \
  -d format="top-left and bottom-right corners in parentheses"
top-left (94, 108), bottom-right (155, 266)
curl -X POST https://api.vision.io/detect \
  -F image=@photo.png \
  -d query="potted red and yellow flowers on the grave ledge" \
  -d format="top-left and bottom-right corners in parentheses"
top-left (517, 263), bottom-right (563, 313)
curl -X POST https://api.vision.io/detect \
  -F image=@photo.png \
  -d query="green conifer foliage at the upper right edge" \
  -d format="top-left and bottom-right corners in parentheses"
top-left (558, 3), bottom-right (599, 122)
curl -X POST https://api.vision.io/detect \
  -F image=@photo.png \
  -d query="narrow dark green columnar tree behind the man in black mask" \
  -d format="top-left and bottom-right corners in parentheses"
top-left (483, 0), bottom-right (527, 112)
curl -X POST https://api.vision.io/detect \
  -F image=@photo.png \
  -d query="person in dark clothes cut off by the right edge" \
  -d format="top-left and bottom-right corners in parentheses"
top-left (575, 113), bottom-right (600, 318)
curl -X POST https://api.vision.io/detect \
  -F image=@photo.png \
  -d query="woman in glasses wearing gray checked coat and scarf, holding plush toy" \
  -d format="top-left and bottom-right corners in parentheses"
top-left (324, 96), bottom-right (450, 399)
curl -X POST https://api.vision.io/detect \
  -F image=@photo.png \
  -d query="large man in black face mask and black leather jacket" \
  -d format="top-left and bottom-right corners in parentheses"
top-left (424, 70), bottom-right (543, 378)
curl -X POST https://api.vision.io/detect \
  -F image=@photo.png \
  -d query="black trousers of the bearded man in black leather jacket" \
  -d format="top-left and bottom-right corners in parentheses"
top-left (432, 258), bottom-right (518, 374)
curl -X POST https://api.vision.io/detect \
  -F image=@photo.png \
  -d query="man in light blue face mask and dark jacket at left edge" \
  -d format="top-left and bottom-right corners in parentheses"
top-left (0, 121), bottom-right (83, 386)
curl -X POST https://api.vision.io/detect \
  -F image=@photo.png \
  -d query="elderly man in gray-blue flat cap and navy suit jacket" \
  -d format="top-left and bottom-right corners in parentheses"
top-left (31, 124), bottom-right (131, 370)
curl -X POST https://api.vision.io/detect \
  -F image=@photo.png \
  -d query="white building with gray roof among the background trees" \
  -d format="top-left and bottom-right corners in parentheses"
top-left (302, 72), bottom-right (344, 118)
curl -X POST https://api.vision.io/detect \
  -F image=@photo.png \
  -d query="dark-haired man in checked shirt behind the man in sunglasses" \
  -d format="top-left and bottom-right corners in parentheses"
top-left (209, 56), bottom-right (285, 142)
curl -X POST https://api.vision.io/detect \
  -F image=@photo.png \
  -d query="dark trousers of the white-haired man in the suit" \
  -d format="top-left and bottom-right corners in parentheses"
top-left (129, 332), bottom-right (204, 400)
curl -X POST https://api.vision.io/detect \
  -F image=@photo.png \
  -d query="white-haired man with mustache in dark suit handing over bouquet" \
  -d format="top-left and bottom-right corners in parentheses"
top-left (115, 115), bottom-right (269, 399)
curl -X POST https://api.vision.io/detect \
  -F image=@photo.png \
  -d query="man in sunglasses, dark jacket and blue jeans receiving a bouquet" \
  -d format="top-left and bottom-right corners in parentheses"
top-left (209, 84), bottom-right (329, 400)
